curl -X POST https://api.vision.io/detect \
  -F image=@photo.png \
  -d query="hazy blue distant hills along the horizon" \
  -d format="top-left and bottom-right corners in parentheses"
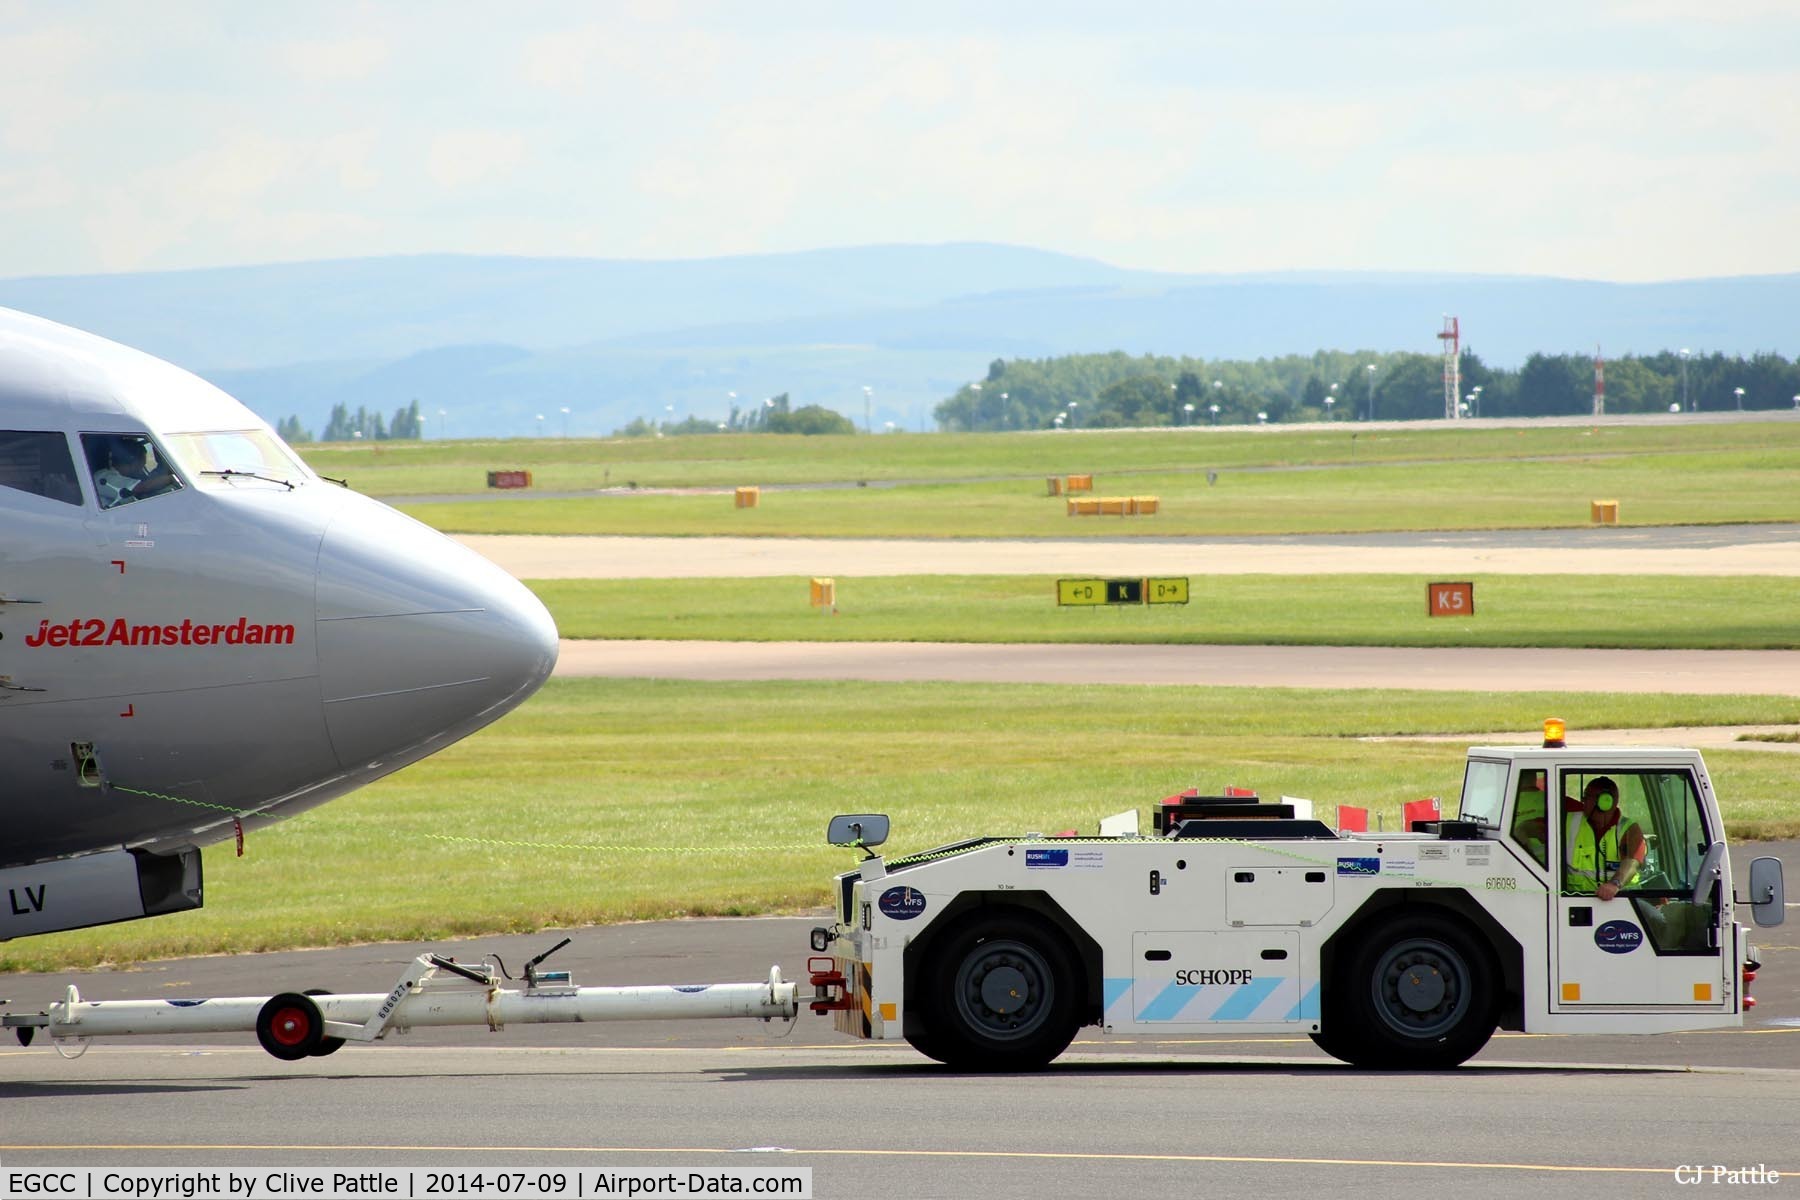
top-left (0, 245), bottom-right (1800, 437)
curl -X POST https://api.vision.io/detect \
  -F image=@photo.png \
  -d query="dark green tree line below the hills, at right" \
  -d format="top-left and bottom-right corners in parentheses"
top-left (934, 351), bottom-right (1800, 432)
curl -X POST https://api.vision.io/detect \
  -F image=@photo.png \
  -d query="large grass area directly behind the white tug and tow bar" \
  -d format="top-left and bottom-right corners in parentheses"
top-left (14, 680), bottom-right (1800, 970)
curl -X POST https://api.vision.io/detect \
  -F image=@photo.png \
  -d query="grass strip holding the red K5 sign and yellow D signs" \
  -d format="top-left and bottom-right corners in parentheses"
top-left (531, 576), bottom-right (1800, 649)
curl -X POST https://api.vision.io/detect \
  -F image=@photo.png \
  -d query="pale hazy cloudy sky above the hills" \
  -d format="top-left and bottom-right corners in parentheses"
top-left (0, 0), bottom-right (1800, 281)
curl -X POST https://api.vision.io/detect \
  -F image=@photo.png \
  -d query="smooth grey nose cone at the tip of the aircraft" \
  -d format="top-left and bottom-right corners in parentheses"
top-left (317, 497), bottom-right (556, 770)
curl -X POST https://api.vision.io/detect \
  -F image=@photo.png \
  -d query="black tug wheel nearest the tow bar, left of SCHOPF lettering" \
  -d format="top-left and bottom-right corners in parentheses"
top-left (913, 912), bottom-right (1082, 1070)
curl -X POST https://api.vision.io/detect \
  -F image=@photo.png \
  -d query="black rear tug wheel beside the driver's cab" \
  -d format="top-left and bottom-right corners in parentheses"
top-left (1314, 914), bottom-right (1499, 1070)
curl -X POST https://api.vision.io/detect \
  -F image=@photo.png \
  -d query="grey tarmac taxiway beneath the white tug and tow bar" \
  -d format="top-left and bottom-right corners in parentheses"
top-left (0, 842), bottom-right (1800, 1198)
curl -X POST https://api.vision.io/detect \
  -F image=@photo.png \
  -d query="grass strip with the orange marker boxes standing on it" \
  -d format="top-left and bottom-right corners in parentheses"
top-left (400, 448), bottom-right (1800, 538)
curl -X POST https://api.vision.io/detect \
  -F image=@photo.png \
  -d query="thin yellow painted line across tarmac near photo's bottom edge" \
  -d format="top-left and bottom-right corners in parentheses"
top-left (0, 1142), bottom-right (1713, 1175)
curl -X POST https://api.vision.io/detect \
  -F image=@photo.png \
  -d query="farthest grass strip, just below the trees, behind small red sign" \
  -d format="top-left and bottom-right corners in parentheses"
top-left (301, 421), bottom-right (1800, 497)
